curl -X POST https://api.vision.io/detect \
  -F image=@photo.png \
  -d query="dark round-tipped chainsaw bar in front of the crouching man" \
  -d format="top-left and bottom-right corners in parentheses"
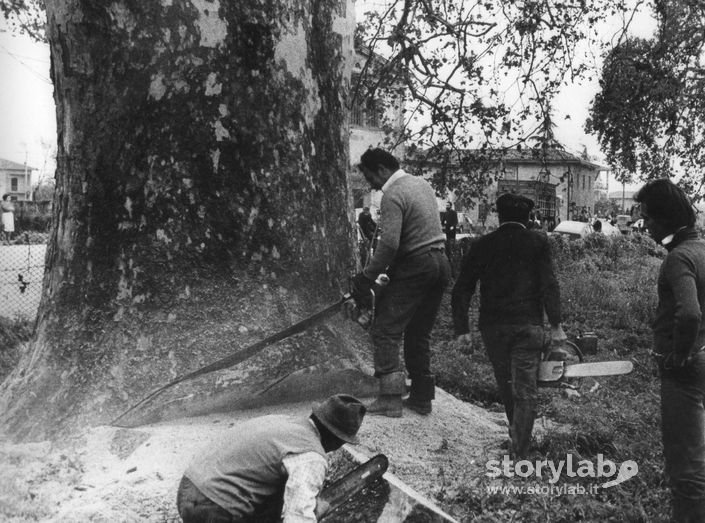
top-left (315, 454), bottom-right (389, 521)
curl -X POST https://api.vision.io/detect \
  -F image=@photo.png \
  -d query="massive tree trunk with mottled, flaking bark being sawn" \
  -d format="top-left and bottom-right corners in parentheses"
top-left (0, 0), bottom-right (374, 438)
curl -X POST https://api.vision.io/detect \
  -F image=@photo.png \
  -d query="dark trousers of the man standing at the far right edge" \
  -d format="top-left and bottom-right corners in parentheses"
top-left (661, 352), bottom-right (705, 523)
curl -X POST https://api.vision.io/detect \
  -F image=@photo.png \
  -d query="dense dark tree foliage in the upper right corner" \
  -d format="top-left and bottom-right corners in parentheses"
top-left (586, 0), bottom-right (705, 193)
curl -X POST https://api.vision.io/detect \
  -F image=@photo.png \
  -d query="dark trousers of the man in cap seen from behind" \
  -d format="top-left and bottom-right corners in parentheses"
top-left (480, 324), bottom-right (544, 459)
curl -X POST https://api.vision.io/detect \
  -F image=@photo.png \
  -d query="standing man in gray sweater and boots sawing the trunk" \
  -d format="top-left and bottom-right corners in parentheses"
top-left (353, 149), bottom-right (450, 417)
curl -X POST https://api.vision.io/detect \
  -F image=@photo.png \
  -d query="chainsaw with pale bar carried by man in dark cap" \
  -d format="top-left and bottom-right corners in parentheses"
top-left (538, 341), bottom-right (634, 388)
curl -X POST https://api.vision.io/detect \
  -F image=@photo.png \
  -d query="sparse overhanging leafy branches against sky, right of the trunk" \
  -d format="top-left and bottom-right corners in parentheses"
top-left (358, 0), bottom-right (634, 201)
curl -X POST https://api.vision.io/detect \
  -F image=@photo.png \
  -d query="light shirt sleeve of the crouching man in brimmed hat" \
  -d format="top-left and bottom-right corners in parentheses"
top-left (282, 452), bottom-right (328, 523)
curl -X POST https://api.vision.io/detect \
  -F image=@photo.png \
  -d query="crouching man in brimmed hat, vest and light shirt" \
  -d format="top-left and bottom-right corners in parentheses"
top-left (176, 394), bottom-right (366, 523)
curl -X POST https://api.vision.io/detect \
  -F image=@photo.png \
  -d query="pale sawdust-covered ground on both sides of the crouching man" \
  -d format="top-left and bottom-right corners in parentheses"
top-left (0, 389), bottom-right (506, 522)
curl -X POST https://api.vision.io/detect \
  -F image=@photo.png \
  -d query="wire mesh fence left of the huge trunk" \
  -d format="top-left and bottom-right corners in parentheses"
top-left (0, 237), bottom-right (46, 320)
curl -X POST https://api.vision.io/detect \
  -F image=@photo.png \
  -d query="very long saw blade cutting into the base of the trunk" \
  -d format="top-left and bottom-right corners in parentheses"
top-left (112, 294), bottom-right (351, 426)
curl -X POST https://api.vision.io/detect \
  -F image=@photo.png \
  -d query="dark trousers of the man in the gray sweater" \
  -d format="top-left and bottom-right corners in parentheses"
top-left (371, 248), bottom-right (450, 380)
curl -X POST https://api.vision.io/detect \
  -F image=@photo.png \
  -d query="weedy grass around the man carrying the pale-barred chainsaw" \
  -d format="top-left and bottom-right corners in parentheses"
top-left (434, 236), bottom-right (669, 522)
